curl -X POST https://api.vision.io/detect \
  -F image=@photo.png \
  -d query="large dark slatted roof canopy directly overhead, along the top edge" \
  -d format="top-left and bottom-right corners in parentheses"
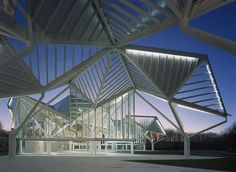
top-left (23, 0), bottom-right (230, 46)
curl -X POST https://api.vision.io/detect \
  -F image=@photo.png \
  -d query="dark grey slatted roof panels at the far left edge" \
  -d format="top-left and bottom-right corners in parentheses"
top-left (0, 39), bottom-right (40, 98)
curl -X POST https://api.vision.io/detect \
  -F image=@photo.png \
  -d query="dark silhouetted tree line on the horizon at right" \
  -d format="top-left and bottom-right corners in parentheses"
top-left (147, 122), bottom-right (236, 150)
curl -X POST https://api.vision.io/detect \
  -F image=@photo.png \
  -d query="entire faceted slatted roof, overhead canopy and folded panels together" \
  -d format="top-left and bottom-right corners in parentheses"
top-left (0, 0), bottom-right (230, 118)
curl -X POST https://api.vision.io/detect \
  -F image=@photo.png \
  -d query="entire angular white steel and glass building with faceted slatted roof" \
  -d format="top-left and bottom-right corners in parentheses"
top-left (0, 0), bottom-right (232, 156)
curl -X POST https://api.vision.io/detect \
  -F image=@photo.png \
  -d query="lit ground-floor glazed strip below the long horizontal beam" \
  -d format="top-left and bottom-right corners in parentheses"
top-left (18, 140), bottom-right (145, 155)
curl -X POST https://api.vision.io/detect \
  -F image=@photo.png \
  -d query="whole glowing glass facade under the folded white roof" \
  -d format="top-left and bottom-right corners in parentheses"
top-left (9, 88), bottom-right (155, 154)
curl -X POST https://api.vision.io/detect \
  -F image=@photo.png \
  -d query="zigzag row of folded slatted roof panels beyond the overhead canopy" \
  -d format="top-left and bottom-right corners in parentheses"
top-left (0, 45), bottom-right (229, 116)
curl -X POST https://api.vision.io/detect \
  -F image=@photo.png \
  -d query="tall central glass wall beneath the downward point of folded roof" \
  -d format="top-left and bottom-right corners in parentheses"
top-left (70, 89), bottom-right (135, 139)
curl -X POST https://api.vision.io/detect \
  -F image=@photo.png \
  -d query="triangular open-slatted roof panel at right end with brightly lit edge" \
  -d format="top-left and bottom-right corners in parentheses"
top-left (174, 62), bottom-right (226, 116)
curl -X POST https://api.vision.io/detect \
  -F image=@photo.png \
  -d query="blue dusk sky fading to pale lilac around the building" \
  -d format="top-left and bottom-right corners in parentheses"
top-left (0, 2), bottom-right (236, 132)
